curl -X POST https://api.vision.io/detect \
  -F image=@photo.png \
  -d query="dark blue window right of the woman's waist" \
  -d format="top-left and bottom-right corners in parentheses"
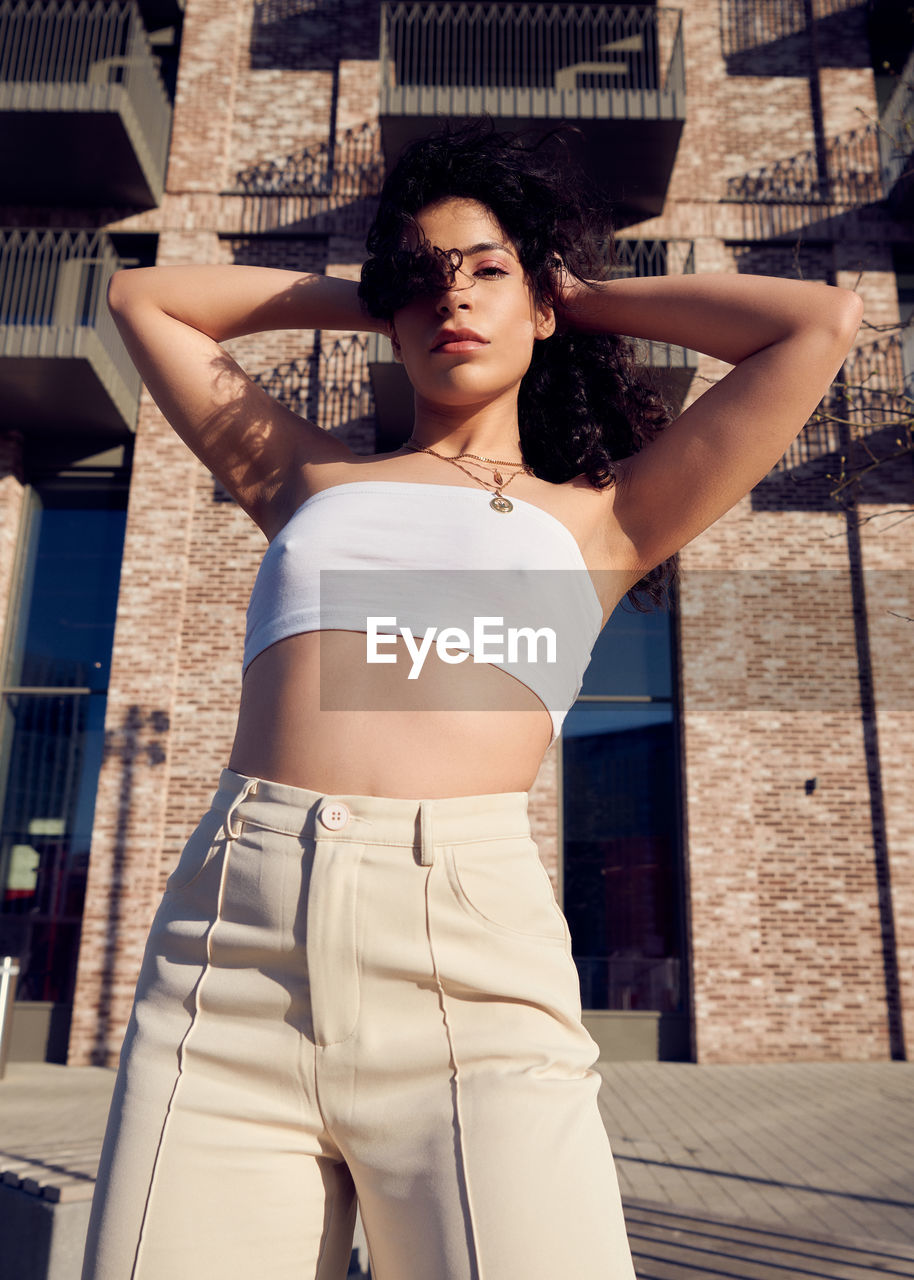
top-left (562, 600), bottom-right (685, 1012)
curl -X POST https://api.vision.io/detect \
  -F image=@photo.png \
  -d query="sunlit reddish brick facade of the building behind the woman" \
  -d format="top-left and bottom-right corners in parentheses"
top-left (65, 0), bottom-right (914, 1064)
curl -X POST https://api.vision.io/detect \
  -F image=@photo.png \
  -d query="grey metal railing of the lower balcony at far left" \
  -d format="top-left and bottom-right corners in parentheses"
top-left (0, 229), bottom-right (140, 429)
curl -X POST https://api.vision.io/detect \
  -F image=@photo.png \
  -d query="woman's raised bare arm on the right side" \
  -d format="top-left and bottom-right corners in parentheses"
top-left (563, 275), bottom-right (863, 581)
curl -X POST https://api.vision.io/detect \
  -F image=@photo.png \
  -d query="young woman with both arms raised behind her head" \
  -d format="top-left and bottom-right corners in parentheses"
top-left (83, 127), bottom-right (862, 1280)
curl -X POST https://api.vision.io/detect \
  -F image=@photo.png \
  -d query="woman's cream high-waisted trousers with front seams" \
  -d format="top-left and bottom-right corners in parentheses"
top-left (83, 769), bottom-right (634, 1280)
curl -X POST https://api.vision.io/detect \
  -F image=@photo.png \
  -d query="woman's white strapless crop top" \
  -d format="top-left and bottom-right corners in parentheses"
top-left (242, 480), bottom-right (603, 745)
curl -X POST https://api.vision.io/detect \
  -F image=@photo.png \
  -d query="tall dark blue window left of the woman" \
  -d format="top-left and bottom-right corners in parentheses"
top-left (0, 476), bottom-right (127, 1002)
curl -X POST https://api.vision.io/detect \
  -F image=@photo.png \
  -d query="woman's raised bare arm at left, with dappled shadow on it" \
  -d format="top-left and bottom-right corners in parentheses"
top-left (108, 266), bottom-right (380, 538)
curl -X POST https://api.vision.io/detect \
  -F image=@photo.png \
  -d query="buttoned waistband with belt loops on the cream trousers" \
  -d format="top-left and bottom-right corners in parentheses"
top-left (212, 769), bottom-right (530, 865)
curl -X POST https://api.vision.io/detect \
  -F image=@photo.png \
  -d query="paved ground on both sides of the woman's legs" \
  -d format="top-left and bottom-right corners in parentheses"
top-left (0, 1062), bottom-right (914, 1280)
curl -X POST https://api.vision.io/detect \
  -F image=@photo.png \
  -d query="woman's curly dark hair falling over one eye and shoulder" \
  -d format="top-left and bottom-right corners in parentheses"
top-left (358, 116), bottom-right (677, 612)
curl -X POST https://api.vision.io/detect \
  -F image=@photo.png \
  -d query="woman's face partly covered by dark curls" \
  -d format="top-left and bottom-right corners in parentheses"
top-left (390, 197), bottom-right (556, 408)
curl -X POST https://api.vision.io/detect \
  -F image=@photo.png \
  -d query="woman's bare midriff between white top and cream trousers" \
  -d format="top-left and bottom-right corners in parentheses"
top-left (229, 631), bottom-right (552, 800)
